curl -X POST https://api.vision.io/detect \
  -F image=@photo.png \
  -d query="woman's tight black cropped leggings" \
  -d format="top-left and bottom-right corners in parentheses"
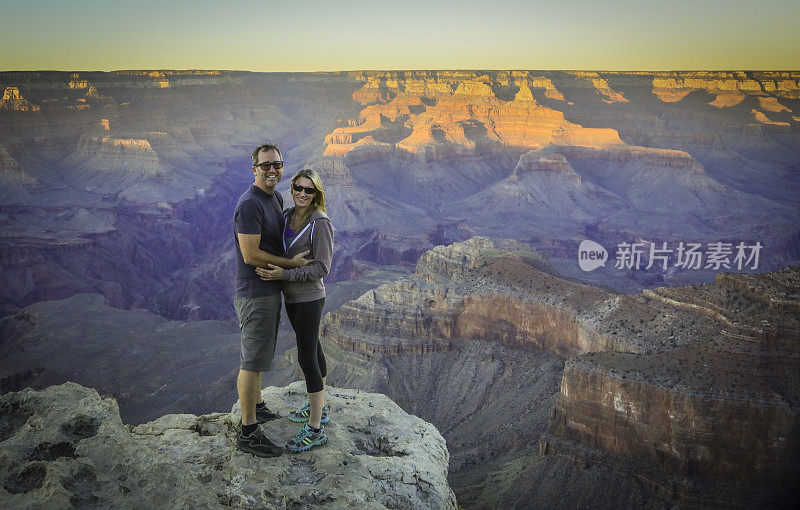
top-left (286, 298), bottom-right (328, 393)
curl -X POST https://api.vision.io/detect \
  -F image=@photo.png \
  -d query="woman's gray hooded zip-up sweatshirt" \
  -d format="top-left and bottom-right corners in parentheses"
top-left (283, 207), bottom-right (333, 303)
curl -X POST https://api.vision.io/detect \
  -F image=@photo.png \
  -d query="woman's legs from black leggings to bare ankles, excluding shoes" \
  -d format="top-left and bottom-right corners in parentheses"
top-left (286, 298), bottom-right (325, 428)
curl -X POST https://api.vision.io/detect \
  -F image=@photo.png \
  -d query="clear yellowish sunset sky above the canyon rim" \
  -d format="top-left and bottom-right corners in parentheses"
top-left (0, 0), bottom-right (800, 71)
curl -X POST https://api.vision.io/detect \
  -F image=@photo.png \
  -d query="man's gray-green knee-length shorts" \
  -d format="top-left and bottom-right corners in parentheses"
top-left (233, 292), bottom-right (281, 372)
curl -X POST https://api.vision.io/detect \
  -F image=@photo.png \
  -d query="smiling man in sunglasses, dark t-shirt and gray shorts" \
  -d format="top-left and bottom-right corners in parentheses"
top-left (233, 144), bottom-right (311, 457)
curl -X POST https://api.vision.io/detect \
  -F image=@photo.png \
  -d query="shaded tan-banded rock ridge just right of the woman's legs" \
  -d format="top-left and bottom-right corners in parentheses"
top-left (322, 237), bottom-right (611, 356)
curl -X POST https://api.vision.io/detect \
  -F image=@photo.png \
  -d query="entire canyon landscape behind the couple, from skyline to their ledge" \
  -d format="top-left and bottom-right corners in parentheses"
top-left (0, 70), bottom-right (800, 508)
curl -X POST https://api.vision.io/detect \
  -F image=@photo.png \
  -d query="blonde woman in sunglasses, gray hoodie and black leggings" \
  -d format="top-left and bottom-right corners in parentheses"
top-left (256, 168), bottom-right (333, 452)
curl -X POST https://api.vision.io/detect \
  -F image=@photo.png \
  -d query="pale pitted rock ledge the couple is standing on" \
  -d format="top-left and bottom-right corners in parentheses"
top-left (0, 383), bottom-right (456, 509)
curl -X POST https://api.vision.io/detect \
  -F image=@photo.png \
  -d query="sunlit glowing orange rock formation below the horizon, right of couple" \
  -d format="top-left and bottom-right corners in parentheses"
top-left (325, 73), bottom-right (624, 160)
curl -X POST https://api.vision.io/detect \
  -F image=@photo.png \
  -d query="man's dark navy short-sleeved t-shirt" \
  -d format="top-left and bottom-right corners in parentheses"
top-left (233, 185), bottom-right (284, 297)
